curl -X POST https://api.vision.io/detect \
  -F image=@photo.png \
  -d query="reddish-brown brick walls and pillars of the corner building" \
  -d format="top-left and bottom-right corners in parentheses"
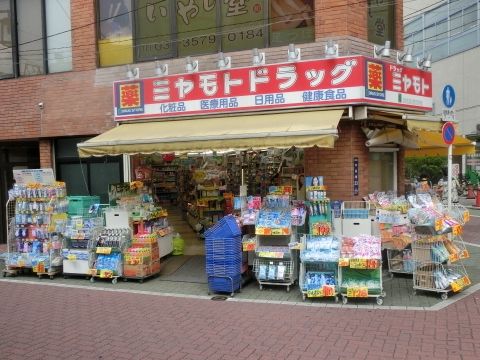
top-left (0, 0), bottom-right (403, 239)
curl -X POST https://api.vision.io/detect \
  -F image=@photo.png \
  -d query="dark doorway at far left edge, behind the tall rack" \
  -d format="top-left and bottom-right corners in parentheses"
top-left (0, 142), bottom-right (40, 244)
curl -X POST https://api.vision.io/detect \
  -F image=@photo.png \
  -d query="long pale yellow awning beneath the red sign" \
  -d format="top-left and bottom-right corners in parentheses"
top-left (77, 109), bottom-right (343, 157)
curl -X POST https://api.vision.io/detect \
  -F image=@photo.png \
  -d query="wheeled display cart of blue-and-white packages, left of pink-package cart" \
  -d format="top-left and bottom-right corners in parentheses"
top-left (299, 235), bottom-right (340, 302)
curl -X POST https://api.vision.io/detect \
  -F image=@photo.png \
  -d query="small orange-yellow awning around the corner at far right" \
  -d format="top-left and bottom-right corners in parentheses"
top-left (405, 130), bottom-right (475, 157)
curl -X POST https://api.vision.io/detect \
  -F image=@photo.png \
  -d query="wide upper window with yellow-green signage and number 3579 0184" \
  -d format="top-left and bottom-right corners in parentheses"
top-left (97, 0), bottom-right (315, 66)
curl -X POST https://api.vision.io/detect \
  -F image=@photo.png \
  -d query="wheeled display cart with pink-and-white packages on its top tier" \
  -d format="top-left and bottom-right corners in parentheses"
top-left (338, 235), bottom-right (386, 305)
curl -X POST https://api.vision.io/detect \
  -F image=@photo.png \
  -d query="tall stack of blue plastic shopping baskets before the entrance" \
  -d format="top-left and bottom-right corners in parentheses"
top-left (204, 215), bottom-right (242, 296)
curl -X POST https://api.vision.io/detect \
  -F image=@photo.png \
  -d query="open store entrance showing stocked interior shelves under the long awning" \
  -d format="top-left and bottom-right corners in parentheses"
top-left (131, 148), bottom-right (304, 261)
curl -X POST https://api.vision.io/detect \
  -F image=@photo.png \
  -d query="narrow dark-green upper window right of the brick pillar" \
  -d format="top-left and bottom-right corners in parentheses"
top-left (367, 0), bottom-right (395, 47)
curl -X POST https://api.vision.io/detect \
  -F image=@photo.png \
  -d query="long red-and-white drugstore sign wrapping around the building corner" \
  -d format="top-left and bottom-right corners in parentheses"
top-left (113, 56), bottom-right (432, 121)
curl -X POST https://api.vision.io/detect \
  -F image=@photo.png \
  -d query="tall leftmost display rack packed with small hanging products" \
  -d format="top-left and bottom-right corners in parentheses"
top-left (3, 181), bottom-right (67, 279)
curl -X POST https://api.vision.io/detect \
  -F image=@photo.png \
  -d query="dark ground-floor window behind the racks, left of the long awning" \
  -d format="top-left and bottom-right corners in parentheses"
top-left (55, 138), bottom-right (123, 204)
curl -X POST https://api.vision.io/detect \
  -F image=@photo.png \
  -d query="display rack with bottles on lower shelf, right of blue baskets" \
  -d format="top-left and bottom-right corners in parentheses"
top-left (253, 193), bottom-right (297, 292)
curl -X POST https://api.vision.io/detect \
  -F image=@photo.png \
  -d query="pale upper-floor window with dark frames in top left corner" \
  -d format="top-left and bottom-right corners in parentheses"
top-left (0, 0), bottom-right (72, 78)
